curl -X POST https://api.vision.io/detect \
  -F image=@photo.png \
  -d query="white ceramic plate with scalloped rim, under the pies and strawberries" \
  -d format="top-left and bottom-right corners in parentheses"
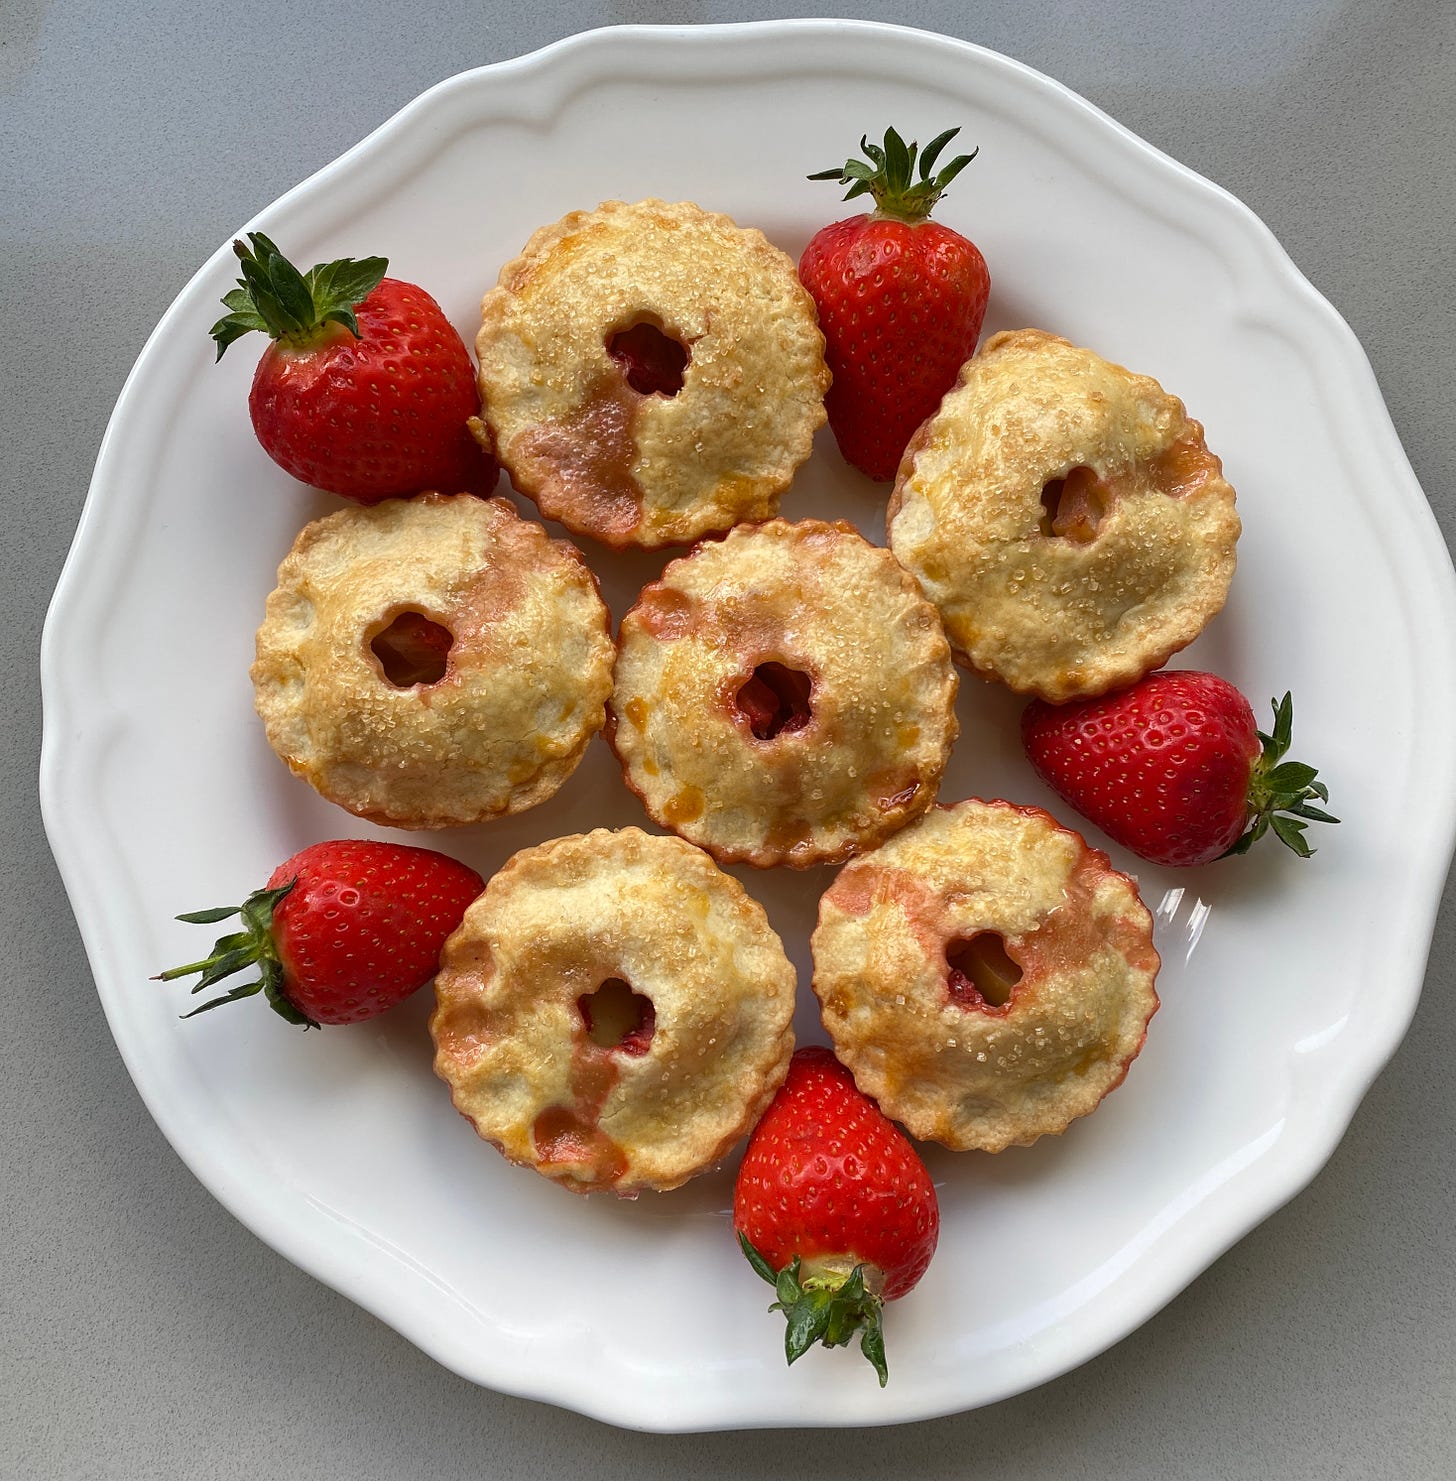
top-left (41, 22), bottom-right (1456, 1429)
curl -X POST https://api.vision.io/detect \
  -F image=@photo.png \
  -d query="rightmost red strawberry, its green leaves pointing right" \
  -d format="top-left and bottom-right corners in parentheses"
top-left (1021, 669), bottom-right (1339, 866)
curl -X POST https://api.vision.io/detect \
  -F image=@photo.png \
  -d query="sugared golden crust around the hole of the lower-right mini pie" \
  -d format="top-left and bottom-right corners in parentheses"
top-left (812, 800), bottom-right (1158, 1152)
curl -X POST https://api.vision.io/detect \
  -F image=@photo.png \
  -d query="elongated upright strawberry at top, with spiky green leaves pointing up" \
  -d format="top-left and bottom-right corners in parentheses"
top-left (798, 129), bottom-right (991, 481)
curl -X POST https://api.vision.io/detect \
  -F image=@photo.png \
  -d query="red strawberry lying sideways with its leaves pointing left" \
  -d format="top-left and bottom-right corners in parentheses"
top-left (153, 838), bottom-right (484, 1029)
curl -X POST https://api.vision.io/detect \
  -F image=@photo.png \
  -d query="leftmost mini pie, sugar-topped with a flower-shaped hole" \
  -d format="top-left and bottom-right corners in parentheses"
top-left (252, 493), bottom-right (615, 828)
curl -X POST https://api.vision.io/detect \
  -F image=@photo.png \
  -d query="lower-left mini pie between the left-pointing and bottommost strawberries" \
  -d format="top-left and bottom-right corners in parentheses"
top-left (430, 828), bottom-right (794, 1195)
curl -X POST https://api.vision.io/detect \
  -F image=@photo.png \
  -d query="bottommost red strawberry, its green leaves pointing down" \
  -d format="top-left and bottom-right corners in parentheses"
top-left (733, 1047), bottom-right (941, 1388)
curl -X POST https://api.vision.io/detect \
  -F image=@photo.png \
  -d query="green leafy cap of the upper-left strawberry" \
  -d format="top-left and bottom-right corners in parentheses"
top-left (209, 231), bottom-right (390, 360)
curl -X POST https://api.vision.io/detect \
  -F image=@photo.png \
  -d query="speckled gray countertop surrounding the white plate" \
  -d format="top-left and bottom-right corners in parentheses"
top-left (0, 0), bottom-right (1456, 1481)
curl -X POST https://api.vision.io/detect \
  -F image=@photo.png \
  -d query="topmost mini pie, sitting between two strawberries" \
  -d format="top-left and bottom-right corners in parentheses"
top-left (475, 200), bottom-right (829, 546)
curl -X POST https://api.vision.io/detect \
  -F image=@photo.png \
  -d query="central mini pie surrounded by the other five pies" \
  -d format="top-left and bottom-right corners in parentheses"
top-left (607, 520), bottom-right (957, 868)
